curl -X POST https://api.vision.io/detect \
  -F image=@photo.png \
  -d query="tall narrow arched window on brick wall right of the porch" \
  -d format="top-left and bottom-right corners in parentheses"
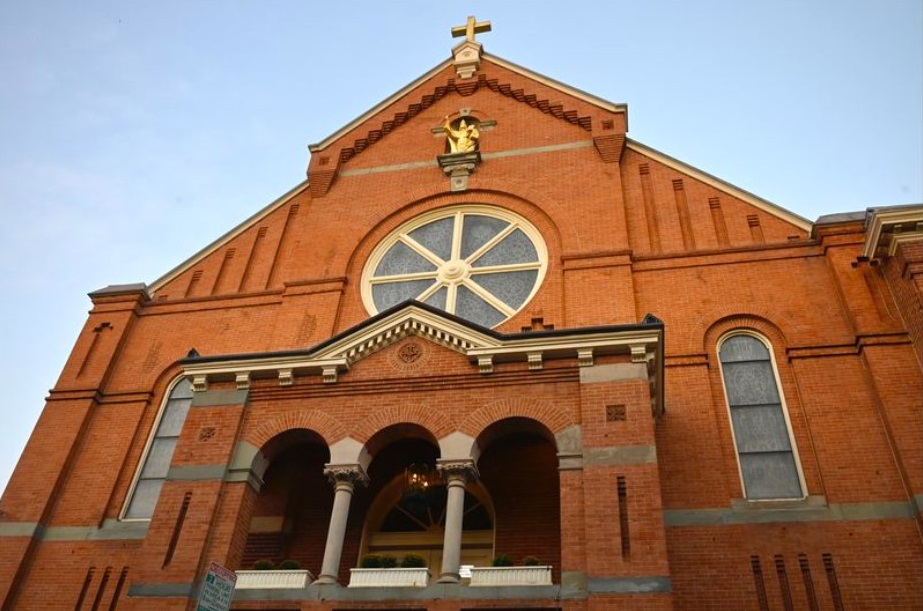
top-left (718, 333), bottom-right (804, 500)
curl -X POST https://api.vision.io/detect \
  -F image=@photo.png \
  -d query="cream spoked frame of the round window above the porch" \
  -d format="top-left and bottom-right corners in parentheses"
top-left (361, 204), bottom-right (548, 328)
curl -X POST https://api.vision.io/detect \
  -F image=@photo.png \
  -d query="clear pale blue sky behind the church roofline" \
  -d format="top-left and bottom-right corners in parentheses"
top-left (0, 0), bottom-right (923, 498)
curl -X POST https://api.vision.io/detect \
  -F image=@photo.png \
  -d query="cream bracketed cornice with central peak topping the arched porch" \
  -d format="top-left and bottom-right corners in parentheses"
top-left (182, 301), bottom-right (663, 414)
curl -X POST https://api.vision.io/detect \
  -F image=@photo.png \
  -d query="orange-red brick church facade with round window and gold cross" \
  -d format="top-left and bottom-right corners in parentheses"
top-left (0, 19), bottom-right (923, 611)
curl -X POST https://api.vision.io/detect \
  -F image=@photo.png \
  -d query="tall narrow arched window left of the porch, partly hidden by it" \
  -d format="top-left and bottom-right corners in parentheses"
top-left (122, 378), bottom-right (192, 520)
